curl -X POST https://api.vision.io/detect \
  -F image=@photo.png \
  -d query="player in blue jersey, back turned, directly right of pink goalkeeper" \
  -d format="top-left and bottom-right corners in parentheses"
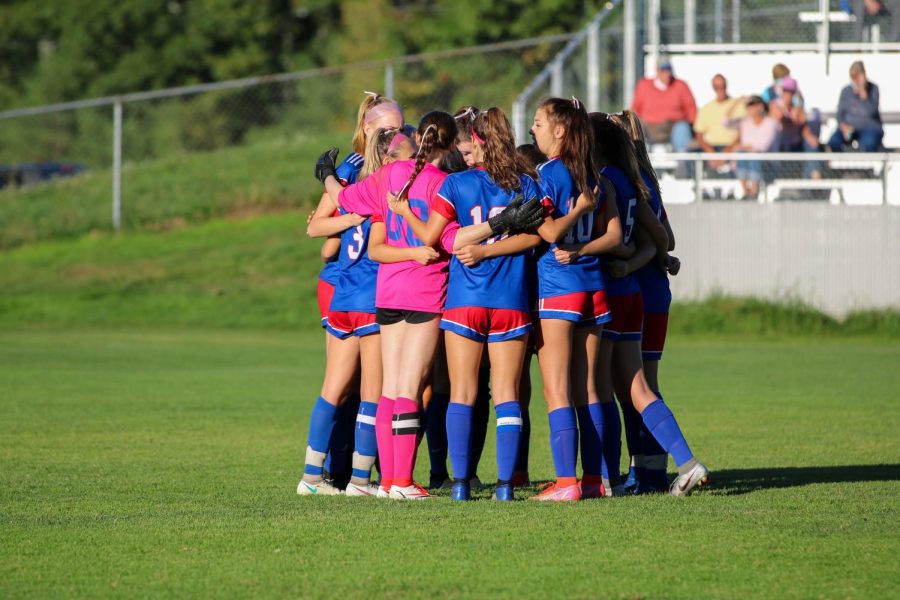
top-left (399, 108), bottom-right (543, 500)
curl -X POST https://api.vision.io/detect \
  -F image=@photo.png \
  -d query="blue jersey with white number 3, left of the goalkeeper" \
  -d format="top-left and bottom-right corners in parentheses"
top-left (330, 210), bottom-right (378, 313)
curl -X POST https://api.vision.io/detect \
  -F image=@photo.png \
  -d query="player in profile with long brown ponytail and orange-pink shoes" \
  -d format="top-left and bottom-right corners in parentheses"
top-left (531, 98), bottom-right (618, 501)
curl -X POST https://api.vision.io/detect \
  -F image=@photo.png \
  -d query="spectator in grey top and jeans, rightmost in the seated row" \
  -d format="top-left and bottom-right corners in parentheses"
top-left (828, 60), bottom-right (884, 152)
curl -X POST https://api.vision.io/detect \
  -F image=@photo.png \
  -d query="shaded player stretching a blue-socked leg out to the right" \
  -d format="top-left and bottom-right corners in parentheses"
top-left (584, 113), bottom-right (709, 496)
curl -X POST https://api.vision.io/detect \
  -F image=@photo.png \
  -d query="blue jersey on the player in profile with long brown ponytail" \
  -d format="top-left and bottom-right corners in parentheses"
top-left (537, 158), bottom-right (604, 298)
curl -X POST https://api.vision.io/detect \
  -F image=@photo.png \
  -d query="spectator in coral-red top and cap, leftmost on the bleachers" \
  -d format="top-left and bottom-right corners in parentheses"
top-left (631, 59), bottom-right (697, 152)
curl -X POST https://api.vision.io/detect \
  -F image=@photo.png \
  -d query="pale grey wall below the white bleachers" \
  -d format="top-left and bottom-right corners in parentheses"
top-left (666, 202), bottom-right (900, 317)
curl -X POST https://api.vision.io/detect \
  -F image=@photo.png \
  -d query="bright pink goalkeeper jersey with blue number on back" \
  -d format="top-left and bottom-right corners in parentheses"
top-left (338, 160), bottom-right (452, 313)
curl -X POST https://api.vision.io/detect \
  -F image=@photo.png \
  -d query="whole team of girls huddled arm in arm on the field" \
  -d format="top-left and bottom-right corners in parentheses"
top-left (297, 94), bottom-right (708, 501)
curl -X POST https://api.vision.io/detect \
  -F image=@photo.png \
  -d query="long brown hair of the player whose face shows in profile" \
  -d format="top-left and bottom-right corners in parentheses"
top-left (539, 97), bottom-right (597, 193)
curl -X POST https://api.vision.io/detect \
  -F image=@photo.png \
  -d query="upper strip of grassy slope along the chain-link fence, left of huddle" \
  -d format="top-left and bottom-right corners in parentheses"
top-left (0, 132), bottom-right (349, 249)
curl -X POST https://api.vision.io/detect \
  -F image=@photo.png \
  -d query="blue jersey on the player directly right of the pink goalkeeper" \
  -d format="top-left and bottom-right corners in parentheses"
top-left (435, 169), bottom-right (543, 311)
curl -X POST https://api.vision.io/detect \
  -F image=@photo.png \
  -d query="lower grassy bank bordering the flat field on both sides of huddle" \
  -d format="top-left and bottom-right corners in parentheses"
top-left (0, 210), bottom-right (900, 337)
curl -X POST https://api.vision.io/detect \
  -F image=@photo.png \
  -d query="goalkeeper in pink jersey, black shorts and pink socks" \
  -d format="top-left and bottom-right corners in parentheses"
top-left (317, 111), bottom-right (457, 499)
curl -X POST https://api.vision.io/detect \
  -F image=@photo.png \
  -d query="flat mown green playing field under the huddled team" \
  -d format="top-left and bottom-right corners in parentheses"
top-left (0, 327), bottom-right (900, 598)
